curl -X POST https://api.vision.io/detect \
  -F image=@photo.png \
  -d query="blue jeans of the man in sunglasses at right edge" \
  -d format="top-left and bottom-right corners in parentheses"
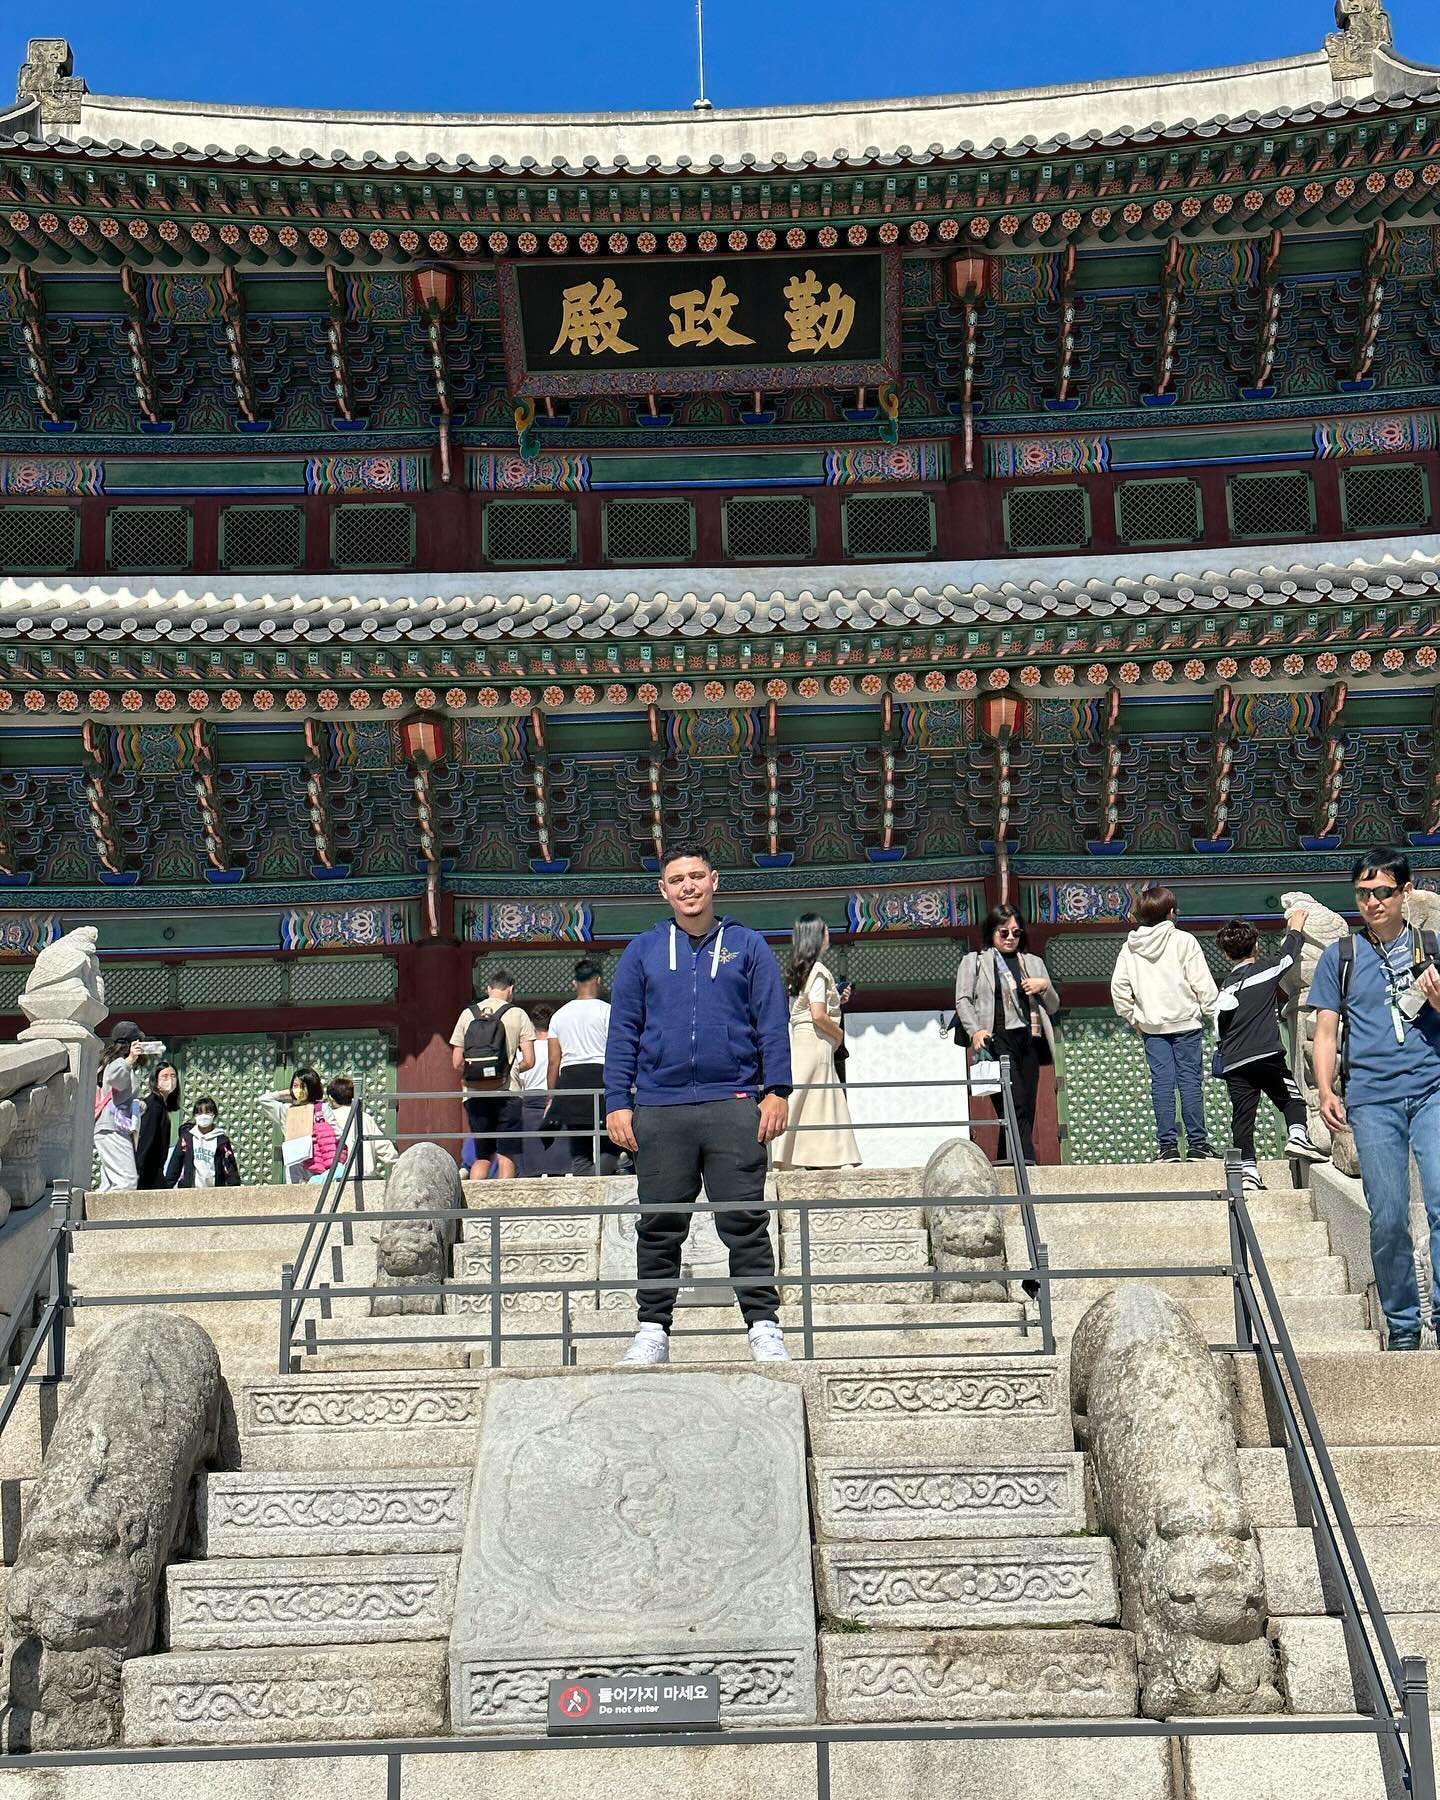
top-left (1345, 1091), bottom-right (1440, 1337)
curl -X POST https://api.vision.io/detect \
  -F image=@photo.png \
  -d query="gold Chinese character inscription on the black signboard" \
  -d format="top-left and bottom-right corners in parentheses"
top-left (551, 268), bottom-right (855, 356)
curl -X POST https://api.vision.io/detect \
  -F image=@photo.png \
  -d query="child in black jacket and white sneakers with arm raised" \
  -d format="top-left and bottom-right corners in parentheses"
top-left (1215, 907), bottom-right (1325, 1190)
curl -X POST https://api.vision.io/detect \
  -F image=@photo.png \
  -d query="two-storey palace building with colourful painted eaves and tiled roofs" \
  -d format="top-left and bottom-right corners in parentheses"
top-left (0, 10), bottom-right (1440, 1168)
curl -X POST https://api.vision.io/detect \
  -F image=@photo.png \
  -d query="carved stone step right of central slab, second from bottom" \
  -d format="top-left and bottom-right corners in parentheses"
top-left (815, 1537), bottom-right (1120, 1631)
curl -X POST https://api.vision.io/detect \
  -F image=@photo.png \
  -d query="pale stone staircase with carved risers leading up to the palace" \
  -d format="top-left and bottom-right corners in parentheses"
top-left (0, 1165), bottom-right (1440, 1800)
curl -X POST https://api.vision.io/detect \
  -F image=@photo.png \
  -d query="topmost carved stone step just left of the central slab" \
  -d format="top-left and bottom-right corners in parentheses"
top-left (236, 1370), bottom-right (486, 1472)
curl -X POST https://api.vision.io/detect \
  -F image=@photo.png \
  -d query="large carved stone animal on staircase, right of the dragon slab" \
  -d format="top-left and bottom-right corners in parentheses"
top-left (1071, 1282), bottom-right (1283, 1719)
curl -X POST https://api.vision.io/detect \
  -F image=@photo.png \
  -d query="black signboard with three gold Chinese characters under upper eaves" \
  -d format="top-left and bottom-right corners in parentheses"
top-left (500, 250), bottom-right (900, 394)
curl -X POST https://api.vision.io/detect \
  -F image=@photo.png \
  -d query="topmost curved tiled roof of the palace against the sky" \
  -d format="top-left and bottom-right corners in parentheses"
top-left (11, 54), bottom-right (1440, 180)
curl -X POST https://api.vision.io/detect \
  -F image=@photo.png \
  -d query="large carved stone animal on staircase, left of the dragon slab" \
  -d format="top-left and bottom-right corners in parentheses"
top-left (5, 1309), bottom-right (220, 1750)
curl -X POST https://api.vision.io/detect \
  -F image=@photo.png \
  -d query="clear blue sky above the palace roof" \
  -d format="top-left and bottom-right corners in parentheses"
top-left (0, 0), bottom-right (1440, 122)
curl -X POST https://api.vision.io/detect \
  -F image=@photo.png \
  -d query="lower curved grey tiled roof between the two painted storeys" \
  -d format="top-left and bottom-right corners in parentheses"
top-left (0, 536), bottom-right (1440, 643)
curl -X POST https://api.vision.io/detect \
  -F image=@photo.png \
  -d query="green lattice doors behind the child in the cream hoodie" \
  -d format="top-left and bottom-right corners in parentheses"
top-left (1057, 1010), bottom-right (1285, 1163)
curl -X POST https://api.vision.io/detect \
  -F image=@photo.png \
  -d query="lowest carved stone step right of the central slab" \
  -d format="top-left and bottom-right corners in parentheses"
top-left (821, 1625), bottom-right (1138, 1720)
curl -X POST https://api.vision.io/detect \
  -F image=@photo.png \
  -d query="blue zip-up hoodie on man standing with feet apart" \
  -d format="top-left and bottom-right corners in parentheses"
top-left (605, 918), bottom-right (790, 1112)
